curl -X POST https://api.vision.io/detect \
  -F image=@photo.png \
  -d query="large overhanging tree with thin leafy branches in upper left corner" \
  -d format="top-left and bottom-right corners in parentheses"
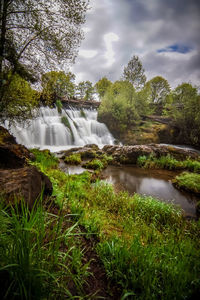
top-left (0, 0), bottom-right (88, 118)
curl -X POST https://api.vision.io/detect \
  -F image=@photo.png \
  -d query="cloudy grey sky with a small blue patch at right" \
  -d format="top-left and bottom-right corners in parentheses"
top-left (71, 0), bottom-right (200, 88)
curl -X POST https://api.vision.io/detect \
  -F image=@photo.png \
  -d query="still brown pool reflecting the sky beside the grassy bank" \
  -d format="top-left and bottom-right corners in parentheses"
top-left (103, 166), bottom-right (197, 217)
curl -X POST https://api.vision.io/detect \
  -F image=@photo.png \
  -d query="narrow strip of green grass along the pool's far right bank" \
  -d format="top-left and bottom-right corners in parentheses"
top-left (137, 155), bottom-right (200, 173)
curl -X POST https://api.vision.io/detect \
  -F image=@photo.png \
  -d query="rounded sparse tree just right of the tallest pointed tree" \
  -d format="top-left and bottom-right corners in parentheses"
top-left (146, 76), bottom-right (170, 104)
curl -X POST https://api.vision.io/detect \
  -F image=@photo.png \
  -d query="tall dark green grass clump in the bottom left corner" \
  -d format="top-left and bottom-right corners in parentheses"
top-left (0, 199), bottom-right (89, 299)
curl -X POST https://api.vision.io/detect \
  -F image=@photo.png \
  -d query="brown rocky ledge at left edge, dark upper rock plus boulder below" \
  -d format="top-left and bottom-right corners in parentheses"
top-left (0, 126), bottom-right (52, 208)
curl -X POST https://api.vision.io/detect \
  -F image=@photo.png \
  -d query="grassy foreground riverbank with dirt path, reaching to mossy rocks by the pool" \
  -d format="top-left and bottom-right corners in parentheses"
top-left (0, 128), bottom-right (200, 300)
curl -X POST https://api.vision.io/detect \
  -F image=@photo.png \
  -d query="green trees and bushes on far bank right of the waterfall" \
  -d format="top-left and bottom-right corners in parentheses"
top-left (96, 56), bottom-right (200, 146)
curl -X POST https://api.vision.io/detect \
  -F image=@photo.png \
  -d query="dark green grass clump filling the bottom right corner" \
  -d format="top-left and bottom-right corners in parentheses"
top-left (98, 234), bottom-right (200, 300)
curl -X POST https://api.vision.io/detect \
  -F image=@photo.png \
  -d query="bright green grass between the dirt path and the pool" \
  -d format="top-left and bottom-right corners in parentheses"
top-left (6, 150), bottom-right (200, 299)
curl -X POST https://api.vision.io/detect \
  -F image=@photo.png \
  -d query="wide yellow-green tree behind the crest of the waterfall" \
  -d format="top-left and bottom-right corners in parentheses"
top-left (42, 71), bottom-right (75, 104)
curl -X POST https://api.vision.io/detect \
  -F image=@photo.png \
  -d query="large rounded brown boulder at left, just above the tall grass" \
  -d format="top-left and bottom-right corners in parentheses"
top-left (0, 166), bottom-right (53, 209)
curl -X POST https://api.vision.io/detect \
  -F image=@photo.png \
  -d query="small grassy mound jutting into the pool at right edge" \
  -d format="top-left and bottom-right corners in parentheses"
top-left (173, 172), bottom-right (200, 194)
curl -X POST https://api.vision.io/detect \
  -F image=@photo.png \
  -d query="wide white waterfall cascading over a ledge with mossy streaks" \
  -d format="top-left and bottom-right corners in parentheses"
top-left (6, 107), bottom-right (114, 152)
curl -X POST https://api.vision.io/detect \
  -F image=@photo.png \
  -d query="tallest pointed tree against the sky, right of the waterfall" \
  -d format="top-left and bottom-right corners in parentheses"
top-left (123, 55), bottom-right (146, 90)
